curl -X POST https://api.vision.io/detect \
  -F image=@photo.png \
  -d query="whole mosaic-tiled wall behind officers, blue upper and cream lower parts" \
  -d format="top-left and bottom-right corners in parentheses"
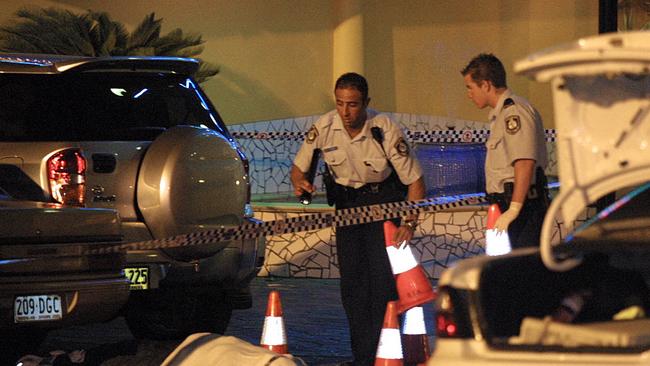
top-left (235, 113), bottom-right (564, 280)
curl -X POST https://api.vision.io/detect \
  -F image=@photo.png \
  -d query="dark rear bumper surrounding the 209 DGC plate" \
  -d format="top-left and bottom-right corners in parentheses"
top-left (0, 273), bottom-right (129, 329)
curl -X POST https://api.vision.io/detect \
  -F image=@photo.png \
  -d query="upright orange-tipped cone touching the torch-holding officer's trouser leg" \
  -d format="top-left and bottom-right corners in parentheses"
top-left (375, 301), bottom-right (404, 366)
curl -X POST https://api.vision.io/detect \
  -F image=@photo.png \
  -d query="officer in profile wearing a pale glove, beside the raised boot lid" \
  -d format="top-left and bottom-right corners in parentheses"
top-left (461, 54), bottom-right (549, 248)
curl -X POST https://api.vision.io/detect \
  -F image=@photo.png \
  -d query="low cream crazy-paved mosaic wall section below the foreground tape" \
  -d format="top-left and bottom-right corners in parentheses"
top-left (255, 206), bottom-right (594, 280)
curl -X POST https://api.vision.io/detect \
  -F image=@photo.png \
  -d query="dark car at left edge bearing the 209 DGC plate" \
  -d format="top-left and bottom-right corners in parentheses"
top-left (0, 193), bottom-right (129, 365)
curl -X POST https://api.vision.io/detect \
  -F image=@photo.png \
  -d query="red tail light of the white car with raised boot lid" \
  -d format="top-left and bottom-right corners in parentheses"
top-left (435, 288), bottom-right (472, 338)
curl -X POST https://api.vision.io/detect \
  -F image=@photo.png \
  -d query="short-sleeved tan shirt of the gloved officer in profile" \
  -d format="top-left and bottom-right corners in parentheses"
top-left (485, 89), bottom-right (547, 193)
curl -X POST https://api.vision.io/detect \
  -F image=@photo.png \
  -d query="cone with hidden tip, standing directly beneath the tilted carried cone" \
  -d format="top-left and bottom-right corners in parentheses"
top-left (402, 306), bottom-right (431, 366)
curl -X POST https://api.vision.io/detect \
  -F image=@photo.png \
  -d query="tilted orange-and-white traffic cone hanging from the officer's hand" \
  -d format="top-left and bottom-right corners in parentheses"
top-left (384, 221), bottom-right (436, 313)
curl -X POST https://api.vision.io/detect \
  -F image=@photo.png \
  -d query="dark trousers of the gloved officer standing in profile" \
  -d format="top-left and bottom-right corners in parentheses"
top-left (487, 183), bottom-right (549, 249)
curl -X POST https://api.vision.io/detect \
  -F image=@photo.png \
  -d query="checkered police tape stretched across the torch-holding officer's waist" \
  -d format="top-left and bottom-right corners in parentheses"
top-left (84, 193), bottom-right (486, 254)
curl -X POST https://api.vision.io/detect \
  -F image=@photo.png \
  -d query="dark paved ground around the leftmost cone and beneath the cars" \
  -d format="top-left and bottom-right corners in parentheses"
top-left (12, 277), bottom-right (433, 366)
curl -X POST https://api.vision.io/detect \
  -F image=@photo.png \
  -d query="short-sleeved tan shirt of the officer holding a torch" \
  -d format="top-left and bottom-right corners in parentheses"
top-left (293, 109), bottom-right (422, 188)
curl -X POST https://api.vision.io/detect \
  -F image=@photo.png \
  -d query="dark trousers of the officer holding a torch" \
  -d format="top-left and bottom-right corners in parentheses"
top-left (336, 183), bottom-right (404, 365)
